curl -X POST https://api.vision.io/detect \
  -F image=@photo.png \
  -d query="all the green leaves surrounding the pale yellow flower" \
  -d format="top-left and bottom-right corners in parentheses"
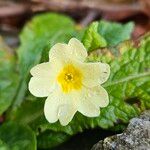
top-left (0, 13), bottom-right (150, 150)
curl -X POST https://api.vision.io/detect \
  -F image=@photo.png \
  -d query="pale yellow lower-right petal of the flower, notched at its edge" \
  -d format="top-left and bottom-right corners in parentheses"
top-left (77, 85), bottom-right (109, 117)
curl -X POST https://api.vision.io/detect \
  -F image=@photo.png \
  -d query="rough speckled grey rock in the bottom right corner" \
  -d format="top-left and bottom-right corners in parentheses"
top-left (92, 110), bottom-right (150, 150)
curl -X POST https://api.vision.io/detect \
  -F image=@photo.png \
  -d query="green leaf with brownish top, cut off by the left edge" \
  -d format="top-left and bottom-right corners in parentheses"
top-left (0, 37), bottom-right (19, 115)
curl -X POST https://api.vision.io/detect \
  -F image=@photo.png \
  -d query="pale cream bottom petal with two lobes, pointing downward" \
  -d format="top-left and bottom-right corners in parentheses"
top-left (44, 85), bottom-right (77, 126)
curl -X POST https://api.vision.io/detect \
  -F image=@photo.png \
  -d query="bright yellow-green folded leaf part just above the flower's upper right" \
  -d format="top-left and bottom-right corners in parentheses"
top-left (82, 22), bottom-right (107, 51)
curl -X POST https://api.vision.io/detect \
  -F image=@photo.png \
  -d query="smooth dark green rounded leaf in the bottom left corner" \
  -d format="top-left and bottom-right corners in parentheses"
top-left (0, 122), bottom-right (36, 150)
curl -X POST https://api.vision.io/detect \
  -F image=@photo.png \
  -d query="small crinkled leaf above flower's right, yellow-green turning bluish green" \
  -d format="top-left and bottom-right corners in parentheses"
top-left (82, 20), bottom-right (134, 53)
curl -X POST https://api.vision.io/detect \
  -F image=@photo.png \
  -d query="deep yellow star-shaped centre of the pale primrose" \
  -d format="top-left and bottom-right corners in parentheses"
top-left (57, 64), bottom-right (82, 93)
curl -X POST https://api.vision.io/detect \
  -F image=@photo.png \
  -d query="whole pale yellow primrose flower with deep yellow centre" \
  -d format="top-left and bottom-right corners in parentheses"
top-left (29, 38), bottom-right (110, 126)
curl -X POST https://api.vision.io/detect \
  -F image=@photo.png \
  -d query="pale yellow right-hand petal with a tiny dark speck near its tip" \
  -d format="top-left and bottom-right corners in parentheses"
top-left (80, 62), bottom-right (110, 87)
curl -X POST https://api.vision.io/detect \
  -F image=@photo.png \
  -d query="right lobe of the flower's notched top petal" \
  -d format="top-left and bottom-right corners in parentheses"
top-left (68, 38), bottom-right (88, 61)
